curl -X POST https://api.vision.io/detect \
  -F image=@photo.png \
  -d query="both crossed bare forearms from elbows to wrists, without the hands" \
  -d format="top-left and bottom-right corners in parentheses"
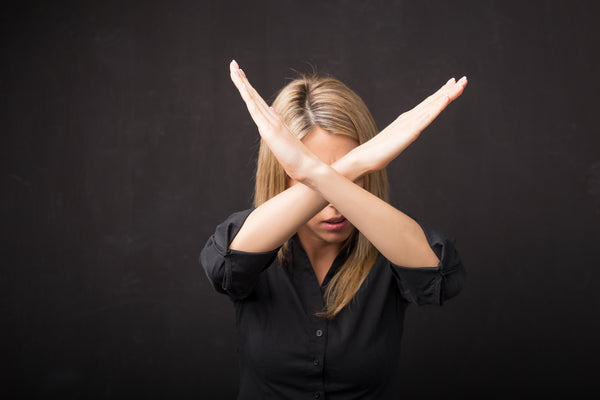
top-left (230, 149), bottom-right (439, 268)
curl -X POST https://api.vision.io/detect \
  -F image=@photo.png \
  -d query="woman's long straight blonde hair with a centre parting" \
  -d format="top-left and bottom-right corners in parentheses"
top-left (254, 74), bottom-right (387, 319)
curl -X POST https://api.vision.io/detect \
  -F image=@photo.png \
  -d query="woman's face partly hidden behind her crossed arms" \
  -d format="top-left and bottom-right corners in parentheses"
top-left (287, 127), bottom-right (362, 246)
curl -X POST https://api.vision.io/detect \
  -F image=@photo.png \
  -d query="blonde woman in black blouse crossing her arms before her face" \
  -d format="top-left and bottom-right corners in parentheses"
top-left (200, 61), bottom-right (467, 399)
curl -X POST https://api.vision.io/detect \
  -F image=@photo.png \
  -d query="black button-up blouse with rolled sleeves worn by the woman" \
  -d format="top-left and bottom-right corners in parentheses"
top-left (200, 209), bottom-right (466, 400)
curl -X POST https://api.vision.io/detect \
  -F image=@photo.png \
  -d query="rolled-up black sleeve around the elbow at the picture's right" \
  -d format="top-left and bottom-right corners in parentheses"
top-left (390, 219), bottom-right (466, 306)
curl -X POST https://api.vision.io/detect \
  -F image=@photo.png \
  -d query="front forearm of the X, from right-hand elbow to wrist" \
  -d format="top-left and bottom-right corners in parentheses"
top-left (303, 163), bottom-right (439, 267)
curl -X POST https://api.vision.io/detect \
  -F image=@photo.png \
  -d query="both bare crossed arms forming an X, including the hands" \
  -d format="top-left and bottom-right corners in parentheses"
top-left (230, 61), bottom-right (467, 267)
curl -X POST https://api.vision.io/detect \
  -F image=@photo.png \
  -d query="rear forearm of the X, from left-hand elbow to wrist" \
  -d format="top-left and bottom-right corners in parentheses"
top-left (229, 153), bottom-right (365, 252)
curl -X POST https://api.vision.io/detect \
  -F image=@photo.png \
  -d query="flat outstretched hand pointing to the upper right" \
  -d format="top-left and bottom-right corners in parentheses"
top-left (350, 77), bottom-right (467, 174)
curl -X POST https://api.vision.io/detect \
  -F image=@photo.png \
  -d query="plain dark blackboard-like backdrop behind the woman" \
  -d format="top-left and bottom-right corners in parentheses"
top-left (0, 0), bottom-right (600, 399)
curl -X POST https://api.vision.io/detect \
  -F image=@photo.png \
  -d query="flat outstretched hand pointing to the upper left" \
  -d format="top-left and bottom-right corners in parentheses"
top-left (229, 60), bottom-right (322, 182)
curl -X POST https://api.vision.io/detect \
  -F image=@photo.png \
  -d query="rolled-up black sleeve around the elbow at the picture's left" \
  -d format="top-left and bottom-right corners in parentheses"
top-left (199, 209), bottom-right (279, 300)
